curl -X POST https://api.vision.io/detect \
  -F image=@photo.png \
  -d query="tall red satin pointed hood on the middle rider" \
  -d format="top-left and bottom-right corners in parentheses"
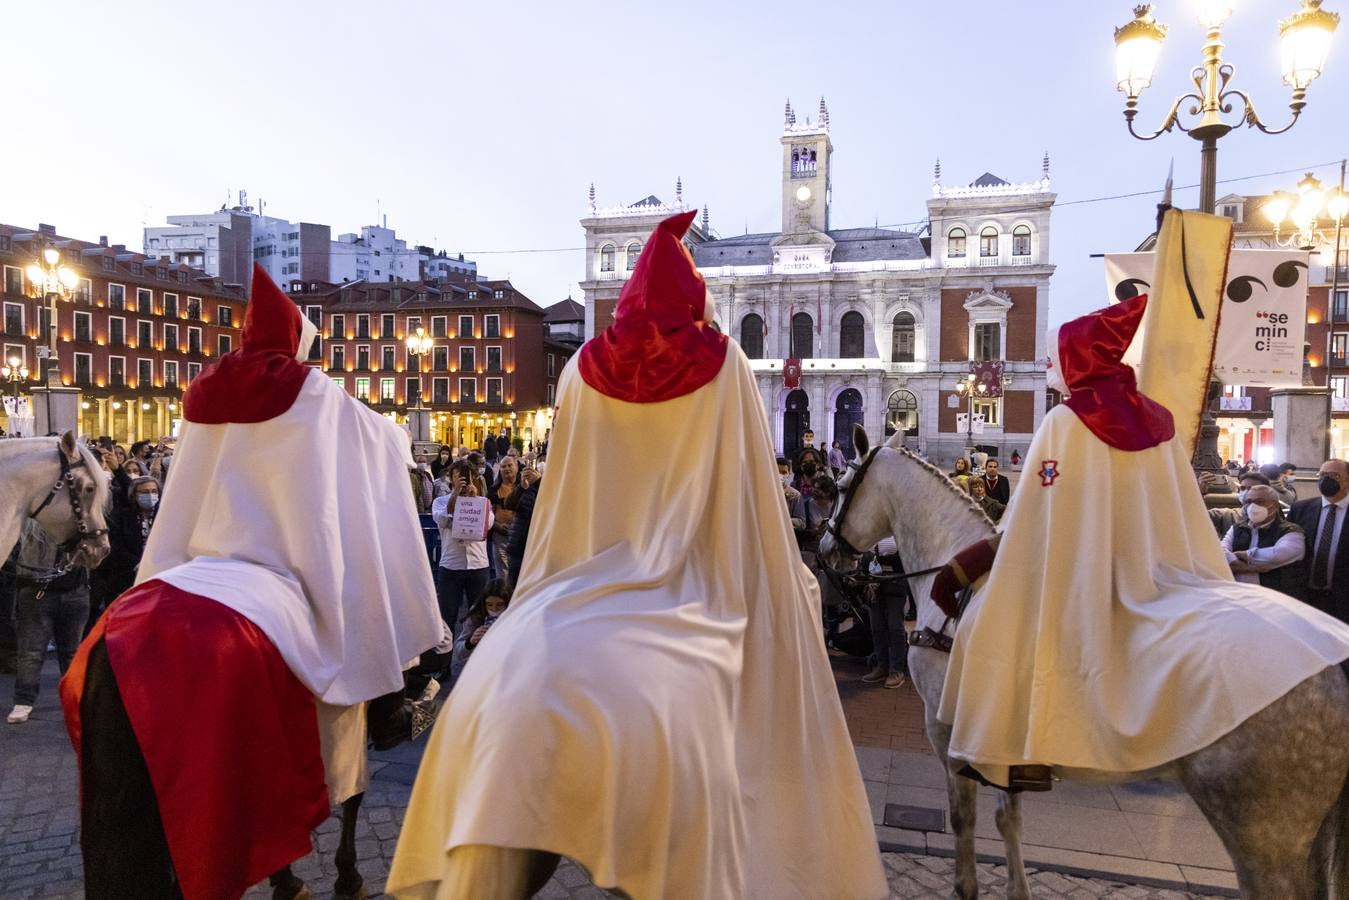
top-left (579, 209), bottom-right (727, 403)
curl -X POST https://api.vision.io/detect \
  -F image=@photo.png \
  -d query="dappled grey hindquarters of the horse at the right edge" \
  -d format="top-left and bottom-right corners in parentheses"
top-left (1178, 667), bottom-right (1349, 900)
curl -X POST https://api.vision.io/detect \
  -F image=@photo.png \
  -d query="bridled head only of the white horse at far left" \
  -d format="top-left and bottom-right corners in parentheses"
top-left (34, 432), bottom-right (109, 568)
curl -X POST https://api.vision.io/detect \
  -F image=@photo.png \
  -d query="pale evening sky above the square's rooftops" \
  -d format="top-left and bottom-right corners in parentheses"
top-left (0, 0), bottom-right (1349, 322)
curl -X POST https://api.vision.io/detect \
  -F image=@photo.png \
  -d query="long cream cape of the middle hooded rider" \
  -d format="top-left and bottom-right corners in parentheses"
top-left (387, 343), bottom-right (886, 900)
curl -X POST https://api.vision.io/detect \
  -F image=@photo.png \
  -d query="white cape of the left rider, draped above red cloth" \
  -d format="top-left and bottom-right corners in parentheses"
top-left (136, 372), bottom-right (441, 803)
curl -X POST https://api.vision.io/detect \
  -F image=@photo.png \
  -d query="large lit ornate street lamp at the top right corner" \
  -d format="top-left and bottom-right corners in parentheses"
top-left (1114, 0), bottom-right (1340, 213)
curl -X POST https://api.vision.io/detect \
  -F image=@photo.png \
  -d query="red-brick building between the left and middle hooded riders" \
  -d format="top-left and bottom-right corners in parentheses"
top-left (290, 278), bottom-right (572, 447)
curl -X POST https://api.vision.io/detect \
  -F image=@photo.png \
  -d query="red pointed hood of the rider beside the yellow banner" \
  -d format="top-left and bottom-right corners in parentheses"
top-left (1059, 294), bottom-right (1175, 451)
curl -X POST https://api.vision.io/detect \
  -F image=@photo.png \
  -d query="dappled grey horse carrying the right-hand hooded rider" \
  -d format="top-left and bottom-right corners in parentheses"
top-left (820, 428), bottom-right (1349, 900)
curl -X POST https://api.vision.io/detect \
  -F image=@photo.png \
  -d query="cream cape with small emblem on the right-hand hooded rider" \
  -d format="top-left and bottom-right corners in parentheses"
top-left (938, 406), bottom-right (1349, 784)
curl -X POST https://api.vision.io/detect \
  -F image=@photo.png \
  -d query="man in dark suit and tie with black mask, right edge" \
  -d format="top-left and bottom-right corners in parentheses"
top-left (1288, 459), bottom-right (1349, 622)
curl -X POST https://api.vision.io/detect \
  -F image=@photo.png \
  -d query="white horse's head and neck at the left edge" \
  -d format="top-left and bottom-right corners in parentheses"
top-left (0, 432), bottom-right (109, 568)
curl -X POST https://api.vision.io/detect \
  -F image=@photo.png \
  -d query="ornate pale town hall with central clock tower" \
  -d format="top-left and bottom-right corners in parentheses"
top-left (581, 100), bottom-right (1055, 460)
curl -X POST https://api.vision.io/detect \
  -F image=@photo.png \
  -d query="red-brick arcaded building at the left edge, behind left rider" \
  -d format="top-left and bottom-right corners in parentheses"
top-left (0, 225), bottom-right (244, 443)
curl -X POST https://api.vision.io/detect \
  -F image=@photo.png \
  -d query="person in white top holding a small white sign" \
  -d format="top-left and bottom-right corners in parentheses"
top-left (430, 460), bottom-right (494, 634)
